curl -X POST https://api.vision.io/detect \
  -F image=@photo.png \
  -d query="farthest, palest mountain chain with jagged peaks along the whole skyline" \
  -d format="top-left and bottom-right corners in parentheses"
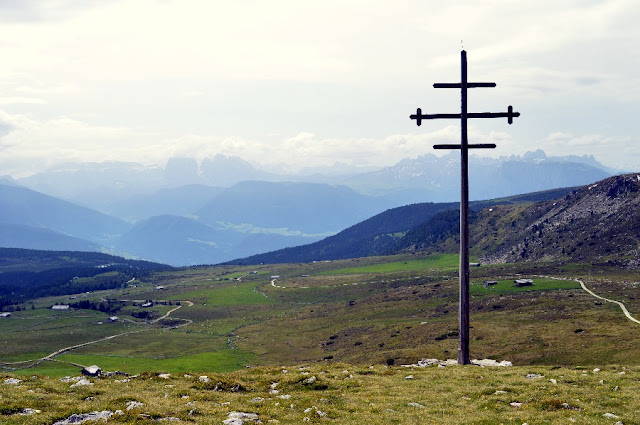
top-left (18, 150), bottom-right (612, 213)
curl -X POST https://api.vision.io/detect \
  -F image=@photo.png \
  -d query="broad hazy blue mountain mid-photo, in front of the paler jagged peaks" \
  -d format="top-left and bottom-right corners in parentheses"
top-left (196, 182), bottom-right (387, 234)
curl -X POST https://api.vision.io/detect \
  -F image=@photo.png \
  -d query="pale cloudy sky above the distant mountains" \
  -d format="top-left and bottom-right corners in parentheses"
top-left (0, 0), bottom-right (640, 177)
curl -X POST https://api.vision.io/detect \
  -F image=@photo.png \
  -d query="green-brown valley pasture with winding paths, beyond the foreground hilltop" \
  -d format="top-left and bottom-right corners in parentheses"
top-left (0, 254), bottom-right (640, 375)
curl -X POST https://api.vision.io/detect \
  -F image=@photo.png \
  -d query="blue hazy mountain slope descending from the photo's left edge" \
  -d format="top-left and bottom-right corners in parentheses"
top-left (0, 185), bottom-right (128, 246)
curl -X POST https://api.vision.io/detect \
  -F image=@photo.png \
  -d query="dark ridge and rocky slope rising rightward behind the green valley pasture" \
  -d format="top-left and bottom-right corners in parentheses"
top-left (230, 173), bottom-right (640, 268)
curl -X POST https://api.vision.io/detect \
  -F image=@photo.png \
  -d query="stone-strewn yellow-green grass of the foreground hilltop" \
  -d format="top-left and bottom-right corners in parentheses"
top-left (0, 364), bottom-right (640, 425)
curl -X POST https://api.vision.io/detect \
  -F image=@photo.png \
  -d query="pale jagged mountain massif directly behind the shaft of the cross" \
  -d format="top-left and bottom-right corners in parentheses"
top-left (344, 150), bottom-right (611, 202)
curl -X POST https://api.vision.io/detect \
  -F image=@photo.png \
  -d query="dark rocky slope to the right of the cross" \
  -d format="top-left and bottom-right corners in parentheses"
top-left (472, 173), bottom-right (640, 267)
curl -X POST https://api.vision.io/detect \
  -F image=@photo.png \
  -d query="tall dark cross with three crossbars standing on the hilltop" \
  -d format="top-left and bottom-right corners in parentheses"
top-left (410, 50), bottom-right (520, 365)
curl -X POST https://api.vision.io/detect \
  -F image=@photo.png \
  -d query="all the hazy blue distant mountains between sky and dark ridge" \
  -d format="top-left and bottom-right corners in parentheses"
top-left (0, 151), bottom-right (610, 266)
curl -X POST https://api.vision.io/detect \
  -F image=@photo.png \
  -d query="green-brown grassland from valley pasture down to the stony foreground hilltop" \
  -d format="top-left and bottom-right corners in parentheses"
top-left (0, 255), bottom-right (640, 424)
